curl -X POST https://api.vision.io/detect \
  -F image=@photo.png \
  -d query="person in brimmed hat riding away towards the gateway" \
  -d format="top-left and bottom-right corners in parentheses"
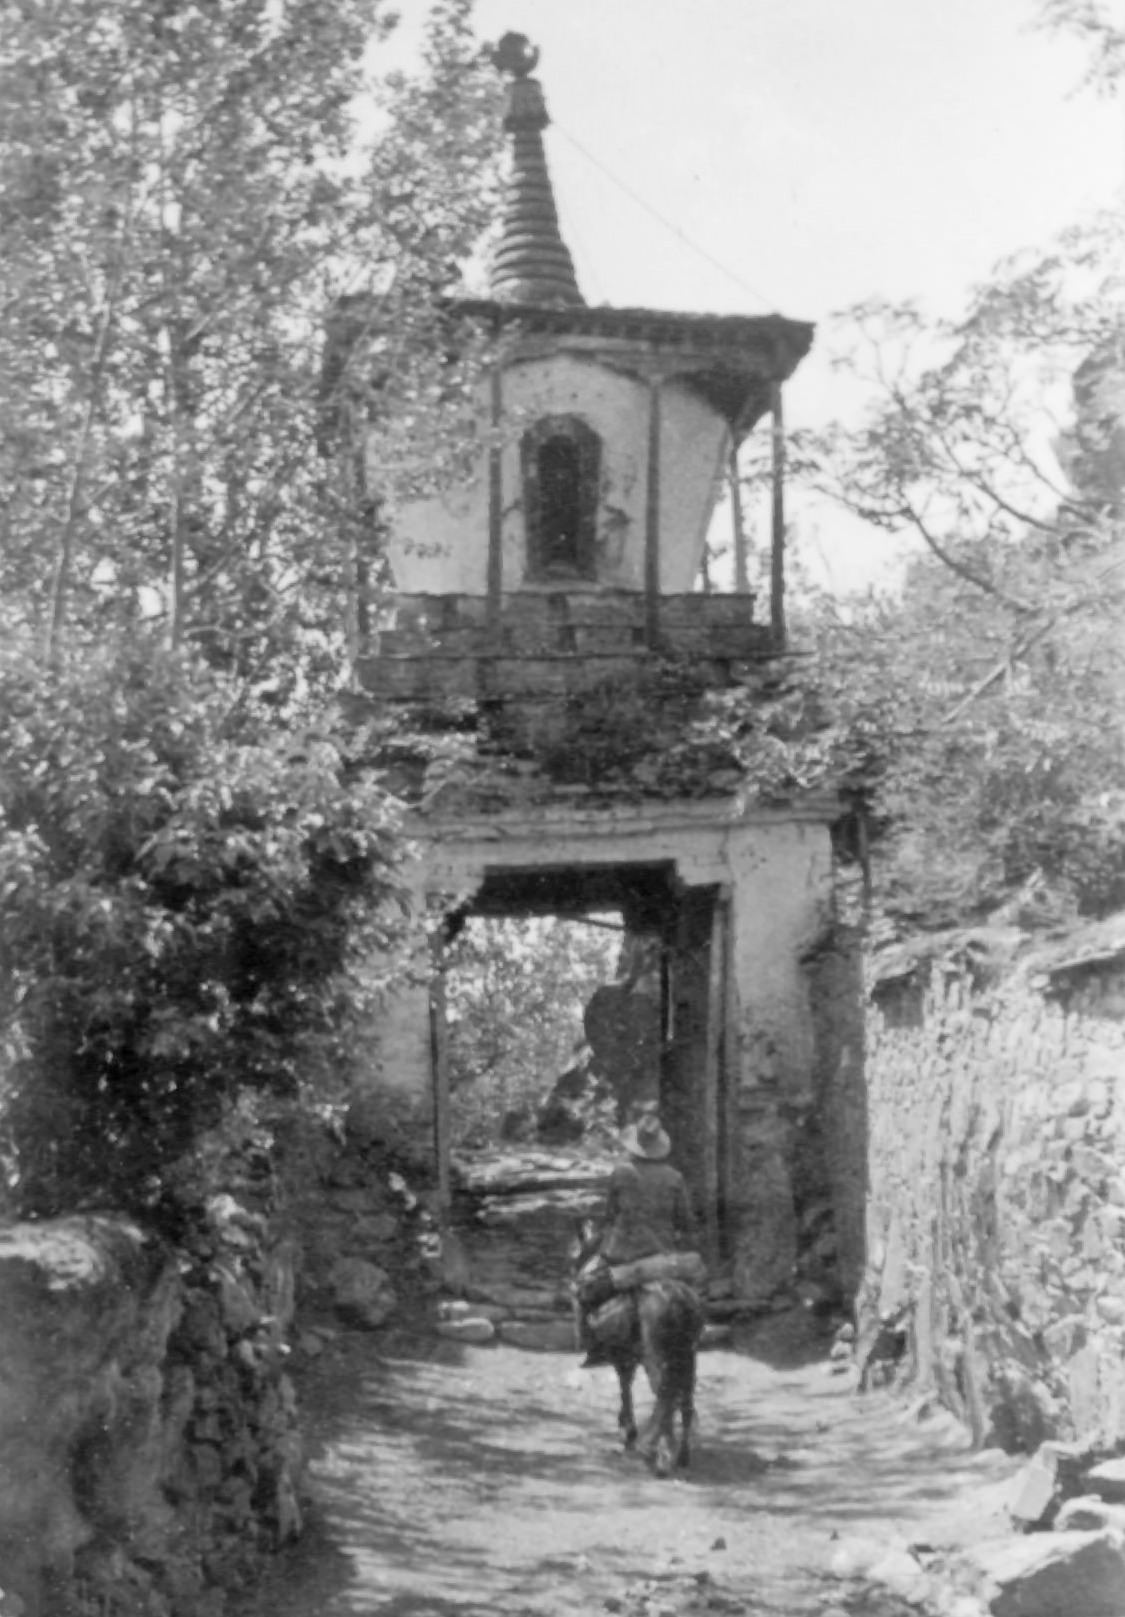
top-left (579, 1111), bottom-right (692, 1370)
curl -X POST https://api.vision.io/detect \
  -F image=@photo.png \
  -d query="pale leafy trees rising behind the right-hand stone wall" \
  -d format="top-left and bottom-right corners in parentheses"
top-left (711, 218), bottom-right (1125, 925)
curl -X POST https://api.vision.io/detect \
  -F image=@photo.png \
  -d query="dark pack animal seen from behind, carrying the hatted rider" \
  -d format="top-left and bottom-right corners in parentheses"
top-left (571, 1219), bottom-right (703, 1476)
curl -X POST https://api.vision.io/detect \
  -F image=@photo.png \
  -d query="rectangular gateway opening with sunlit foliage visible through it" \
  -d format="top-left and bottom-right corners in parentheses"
top-left (436, 862), bottom-right (734, 1258)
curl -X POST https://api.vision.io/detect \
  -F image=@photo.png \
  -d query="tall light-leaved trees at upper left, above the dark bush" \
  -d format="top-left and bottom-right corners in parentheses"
top-left (0, 0), bottom-right (499, 686)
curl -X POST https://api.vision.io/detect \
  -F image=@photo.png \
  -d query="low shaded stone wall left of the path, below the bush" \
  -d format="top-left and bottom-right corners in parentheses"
top-left (0, 1195), bottom-right (301, 1617)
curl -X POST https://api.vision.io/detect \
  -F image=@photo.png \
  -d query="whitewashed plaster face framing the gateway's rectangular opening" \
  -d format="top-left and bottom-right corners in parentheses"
top-left (355, 802), bottom-right (832, 1300)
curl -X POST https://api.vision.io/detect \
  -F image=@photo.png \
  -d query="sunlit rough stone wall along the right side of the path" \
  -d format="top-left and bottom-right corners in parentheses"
top-left (857, 948), bottom-right (1125, 1449)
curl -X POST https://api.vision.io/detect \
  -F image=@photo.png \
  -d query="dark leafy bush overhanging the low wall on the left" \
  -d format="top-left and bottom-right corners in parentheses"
top-left (0, 637), bottom-right (399, 1216)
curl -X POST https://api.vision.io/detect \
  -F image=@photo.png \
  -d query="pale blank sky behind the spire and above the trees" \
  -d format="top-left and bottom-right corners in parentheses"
top-left (391, 0), bottom-right (1125, 588)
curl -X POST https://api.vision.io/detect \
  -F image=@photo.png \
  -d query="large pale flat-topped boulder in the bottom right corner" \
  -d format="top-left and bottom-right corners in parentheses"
top-left (960, 1531), bottom-right (1125, 1617)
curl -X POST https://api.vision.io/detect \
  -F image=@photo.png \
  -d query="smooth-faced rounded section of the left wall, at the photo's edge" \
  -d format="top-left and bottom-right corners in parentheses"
top-left (0, 1214), bottom-right (183, 1617)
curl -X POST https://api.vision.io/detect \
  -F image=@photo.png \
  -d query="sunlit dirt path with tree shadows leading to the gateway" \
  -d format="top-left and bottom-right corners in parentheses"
top-left (247, 1337), bottom-right (1012, 1617)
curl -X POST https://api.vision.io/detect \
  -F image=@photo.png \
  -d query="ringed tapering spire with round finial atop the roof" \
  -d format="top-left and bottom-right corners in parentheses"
top-left (490, 34), bottom-right (585, 304)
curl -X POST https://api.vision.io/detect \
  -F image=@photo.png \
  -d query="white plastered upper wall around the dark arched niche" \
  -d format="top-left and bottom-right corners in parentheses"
top-left (388, 354), bottom-right (729, 595)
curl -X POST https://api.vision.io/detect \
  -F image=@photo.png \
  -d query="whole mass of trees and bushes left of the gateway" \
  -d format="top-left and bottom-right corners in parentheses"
top-left (0, 0), bottom-right (499, 1211)
